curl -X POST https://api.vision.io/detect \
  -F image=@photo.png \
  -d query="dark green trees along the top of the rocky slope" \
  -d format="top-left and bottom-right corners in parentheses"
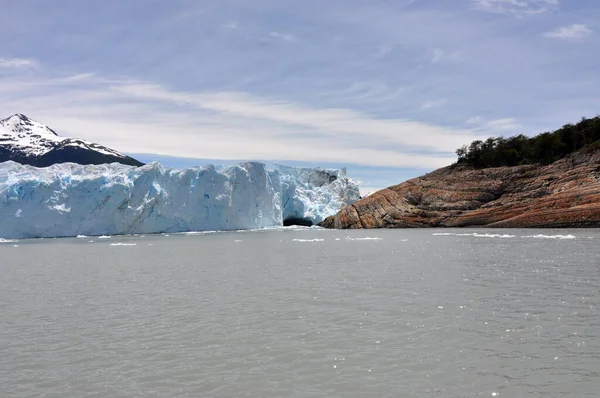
top-left (456, 116), bottom-right (600, 168)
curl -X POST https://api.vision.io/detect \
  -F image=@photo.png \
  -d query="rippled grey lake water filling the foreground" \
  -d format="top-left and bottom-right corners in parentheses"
top-left (0, 229), bottom-right (600, 398)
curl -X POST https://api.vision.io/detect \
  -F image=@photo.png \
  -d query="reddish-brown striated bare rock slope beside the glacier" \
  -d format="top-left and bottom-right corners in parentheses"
top-left (319, 149), bottom-right (600, 229)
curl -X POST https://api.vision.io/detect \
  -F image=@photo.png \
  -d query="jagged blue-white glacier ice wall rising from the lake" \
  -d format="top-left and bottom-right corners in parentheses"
top-left (0, 161), bottom-right (360, 239)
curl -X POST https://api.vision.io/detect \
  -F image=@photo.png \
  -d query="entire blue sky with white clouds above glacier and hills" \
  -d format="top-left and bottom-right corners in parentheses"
top-left (0, 0), bottom-right (600, 193)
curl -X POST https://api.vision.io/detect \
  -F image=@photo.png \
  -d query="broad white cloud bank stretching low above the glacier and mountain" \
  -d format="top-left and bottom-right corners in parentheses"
top-left (0, 74), bottom-right (477, 169)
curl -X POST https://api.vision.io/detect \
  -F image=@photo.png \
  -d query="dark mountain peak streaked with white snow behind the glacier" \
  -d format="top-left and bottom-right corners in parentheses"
top-left (0, 114), bottom-right (143, 167)
